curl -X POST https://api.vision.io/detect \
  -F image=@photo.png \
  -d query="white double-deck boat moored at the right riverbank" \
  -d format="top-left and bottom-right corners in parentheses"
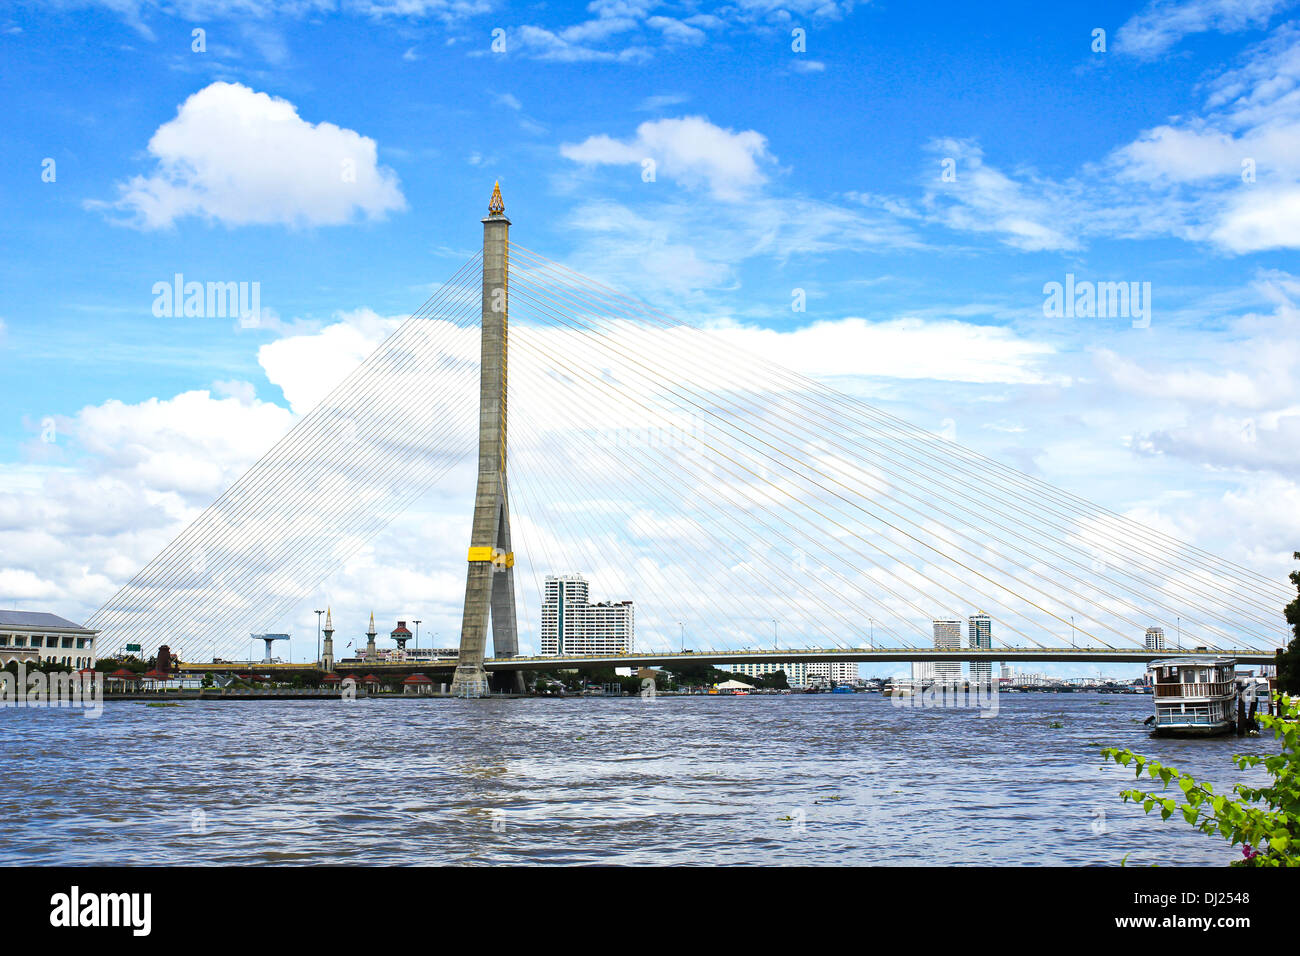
top-left (1148, 657), bottom-right (1238, 737)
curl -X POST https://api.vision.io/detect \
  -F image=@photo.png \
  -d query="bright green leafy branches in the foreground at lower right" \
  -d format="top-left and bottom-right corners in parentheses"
top-left (1101, 695), bottom-right (1300, 866)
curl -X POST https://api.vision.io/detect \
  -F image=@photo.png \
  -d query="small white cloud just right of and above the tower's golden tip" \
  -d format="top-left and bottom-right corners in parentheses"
top-left (560, 116), bottom-right (774, 202)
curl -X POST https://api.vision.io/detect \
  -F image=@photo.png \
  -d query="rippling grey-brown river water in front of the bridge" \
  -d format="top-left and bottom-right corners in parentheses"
top-left (0, 693), bottom-right (1277, 865)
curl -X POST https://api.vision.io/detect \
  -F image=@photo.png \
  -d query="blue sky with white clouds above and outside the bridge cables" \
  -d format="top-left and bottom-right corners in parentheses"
top-left (0, 0), bottom-right (1300, 671)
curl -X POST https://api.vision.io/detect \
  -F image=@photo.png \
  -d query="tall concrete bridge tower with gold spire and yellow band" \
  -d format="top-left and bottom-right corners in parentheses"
top-left (451, 183), bottom-right (519, 696)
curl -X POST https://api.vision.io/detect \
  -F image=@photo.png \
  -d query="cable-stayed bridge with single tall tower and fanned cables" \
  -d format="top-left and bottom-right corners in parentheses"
top-left (88, 184), bottom-right (1294, 693)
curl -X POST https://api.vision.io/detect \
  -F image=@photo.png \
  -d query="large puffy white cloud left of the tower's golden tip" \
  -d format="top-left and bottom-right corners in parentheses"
top-left (92, 82), bottom-right (406, 229)
